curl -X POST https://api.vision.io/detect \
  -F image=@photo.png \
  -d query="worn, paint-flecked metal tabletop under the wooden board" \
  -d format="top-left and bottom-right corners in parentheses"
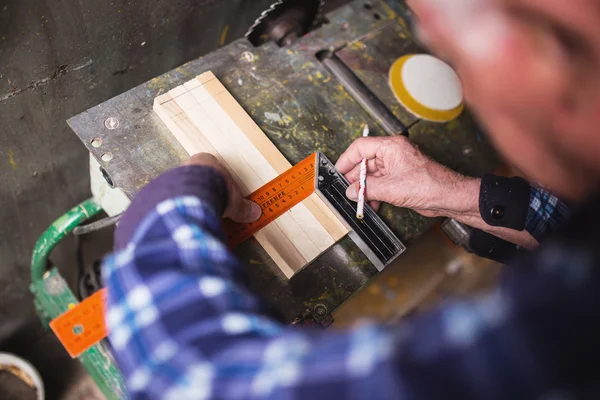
top-left (68, 1), bottom-right (495, 321)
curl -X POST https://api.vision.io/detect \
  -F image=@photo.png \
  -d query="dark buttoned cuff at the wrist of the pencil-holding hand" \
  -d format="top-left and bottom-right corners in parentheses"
top-left (479, 174), bottom-right (530, 231)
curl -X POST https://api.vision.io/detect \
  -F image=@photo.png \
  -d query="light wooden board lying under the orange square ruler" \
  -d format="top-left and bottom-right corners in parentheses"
top-left (154, 72), bottom-right (348, 278)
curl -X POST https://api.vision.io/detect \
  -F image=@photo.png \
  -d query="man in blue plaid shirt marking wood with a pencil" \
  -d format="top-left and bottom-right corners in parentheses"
top-left (103, 0), bottom-right (600, 399)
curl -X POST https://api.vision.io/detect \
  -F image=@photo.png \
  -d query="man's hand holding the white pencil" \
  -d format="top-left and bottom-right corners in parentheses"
top-left (336, 136), bottom-right (479, 217)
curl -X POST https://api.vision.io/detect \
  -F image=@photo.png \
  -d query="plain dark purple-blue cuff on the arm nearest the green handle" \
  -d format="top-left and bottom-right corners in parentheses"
top-left (115, 165), bottom-right (228, 250)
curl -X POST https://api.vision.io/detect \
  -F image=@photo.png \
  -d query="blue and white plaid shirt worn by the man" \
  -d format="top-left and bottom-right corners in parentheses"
top-left (103, 167), bottom-right (600, 400)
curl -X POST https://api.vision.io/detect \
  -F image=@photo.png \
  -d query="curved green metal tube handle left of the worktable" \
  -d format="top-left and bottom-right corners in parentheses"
top-left (31, 198), bottom-right (102, 283)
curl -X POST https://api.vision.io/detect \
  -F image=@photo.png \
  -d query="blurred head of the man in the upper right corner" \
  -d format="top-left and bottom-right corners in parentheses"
top-left (409, 0), bottom-right (600, 199)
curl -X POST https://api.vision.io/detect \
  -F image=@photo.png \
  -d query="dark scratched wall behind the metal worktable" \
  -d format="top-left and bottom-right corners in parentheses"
top-left (0, 0), bottom-right (298, 398)
